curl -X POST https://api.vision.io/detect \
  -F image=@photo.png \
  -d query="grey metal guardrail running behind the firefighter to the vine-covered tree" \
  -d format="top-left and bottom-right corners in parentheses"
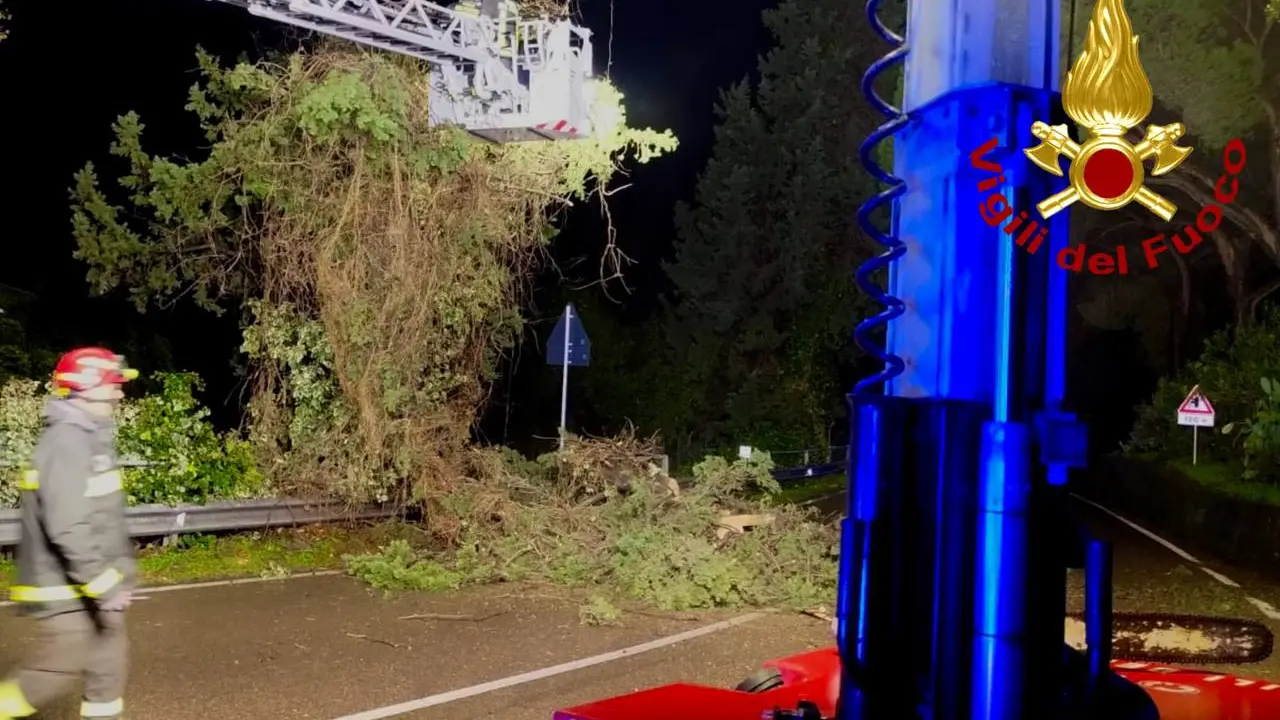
top-left (0, 498), bottom-right (399, 547)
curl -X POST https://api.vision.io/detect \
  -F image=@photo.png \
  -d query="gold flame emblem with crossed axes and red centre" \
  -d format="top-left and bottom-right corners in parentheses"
top-left (1023, 0), bottom-right (1192, 222)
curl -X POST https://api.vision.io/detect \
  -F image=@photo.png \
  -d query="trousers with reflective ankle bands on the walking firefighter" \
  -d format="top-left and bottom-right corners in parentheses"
top-left (0, 610), bottom-right (128, 720)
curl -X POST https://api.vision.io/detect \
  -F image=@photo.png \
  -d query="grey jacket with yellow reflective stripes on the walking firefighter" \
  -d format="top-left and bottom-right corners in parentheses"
top-left (10, 398), bottom-right (136, 615)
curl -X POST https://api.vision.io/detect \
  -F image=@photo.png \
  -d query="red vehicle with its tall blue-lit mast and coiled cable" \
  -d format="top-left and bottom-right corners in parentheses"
top-left (554, 0), bottom-right (1280, 720)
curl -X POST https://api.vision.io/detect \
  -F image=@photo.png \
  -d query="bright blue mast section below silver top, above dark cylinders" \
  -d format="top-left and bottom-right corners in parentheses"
top-left (890, 85), bottom-right (1066, 404)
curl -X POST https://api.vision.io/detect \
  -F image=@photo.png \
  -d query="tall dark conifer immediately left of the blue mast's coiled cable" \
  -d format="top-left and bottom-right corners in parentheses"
top-left (663, 0), bottom-right (892, 448)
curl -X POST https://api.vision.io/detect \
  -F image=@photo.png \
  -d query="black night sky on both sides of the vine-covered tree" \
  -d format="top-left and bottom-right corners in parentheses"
top-left (0, 0), bottom-right (774, 423)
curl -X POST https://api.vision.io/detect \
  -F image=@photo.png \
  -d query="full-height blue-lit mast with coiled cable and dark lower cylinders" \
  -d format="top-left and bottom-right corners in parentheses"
top-left (838, 0), bottom-right (1082, 720)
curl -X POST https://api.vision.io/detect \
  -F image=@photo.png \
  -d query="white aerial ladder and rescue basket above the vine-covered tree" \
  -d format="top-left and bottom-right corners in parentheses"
top-left (207, 0), bottom-right (593, 142)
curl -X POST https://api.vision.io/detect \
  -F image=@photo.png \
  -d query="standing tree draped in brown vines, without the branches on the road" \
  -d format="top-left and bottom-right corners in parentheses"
top-left (74, 42), bottom-right (675, 502)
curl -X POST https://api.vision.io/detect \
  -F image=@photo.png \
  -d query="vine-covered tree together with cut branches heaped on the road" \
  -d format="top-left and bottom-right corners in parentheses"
top-left (62, 8), bottom-right (836, 607)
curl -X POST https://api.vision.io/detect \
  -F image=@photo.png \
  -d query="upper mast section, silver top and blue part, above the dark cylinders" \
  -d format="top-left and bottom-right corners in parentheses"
top-left (890, 0), bottom-right (1066, 404)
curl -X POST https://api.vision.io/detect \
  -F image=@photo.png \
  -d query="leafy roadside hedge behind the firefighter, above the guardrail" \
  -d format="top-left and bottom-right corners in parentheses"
top-left (0, 373), bottom-right (268, 507)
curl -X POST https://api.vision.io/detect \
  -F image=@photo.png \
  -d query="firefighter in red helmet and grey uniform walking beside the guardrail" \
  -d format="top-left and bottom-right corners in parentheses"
top-left (0, 347), bottom-right (137, 720)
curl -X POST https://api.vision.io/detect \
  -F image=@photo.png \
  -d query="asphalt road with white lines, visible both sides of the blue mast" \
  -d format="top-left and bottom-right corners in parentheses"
top-left (0, 491), bottom-right (1280, 720)
